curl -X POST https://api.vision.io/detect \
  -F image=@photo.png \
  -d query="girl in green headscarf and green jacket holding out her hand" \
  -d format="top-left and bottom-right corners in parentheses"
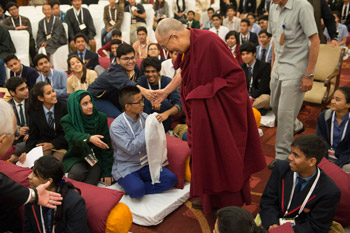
top-left (61, 90), bottom-right (113, 186)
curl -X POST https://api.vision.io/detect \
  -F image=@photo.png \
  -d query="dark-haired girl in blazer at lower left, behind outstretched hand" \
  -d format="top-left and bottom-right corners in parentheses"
top-left (23, 156), bottom-right (90, 233)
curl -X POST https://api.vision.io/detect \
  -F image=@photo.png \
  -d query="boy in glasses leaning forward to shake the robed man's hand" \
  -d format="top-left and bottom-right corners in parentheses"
top-left (88, 44), bottom-right (150, 118)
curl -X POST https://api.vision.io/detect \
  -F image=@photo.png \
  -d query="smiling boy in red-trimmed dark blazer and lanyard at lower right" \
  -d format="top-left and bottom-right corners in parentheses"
top-left (260, 135), bottom-right (340, 233)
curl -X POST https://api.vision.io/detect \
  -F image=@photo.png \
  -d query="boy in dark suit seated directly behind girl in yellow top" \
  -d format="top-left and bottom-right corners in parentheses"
top-left (69, 33), bottom-right (99, 70)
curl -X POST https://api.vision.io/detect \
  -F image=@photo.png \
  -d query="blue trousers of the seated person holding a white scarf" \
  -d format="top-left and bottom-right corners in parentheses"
top-left (117, 165), bottom-right (177, 198)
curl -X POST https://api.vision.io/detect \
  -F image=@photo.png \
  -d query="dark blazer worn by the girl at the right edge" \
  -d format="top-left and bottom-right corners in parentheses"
top-left (316, 109), bottom-right (350, 167)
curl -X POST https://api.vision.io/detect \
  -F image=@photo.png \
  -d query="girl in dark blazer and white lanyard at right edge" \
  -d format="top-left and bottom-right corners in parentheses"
top-left (317, 86), bottom-right (350, 173)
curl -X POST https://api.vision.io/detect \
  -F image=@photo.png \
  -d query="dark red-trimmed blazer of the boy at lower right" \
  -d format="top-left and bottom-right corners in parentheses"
top-left (260, 160), bottom-right (340, 233)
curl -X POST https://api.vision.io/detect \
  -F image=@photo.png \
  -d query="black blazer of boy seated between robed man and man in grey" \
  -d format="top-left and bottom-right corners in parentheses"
top-left (241, 59), bottom-right (271, 98)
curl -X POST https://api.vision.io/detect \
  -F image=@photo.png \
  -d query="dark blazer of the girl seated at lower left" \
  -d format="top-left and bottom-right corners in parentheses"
top-left (23, 189), bottom-right (90, 233)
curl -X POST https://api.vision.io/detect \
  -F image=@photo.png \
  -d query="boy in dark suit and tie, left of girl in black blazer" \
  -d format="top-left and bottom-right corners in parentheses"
top-left (6, 77), bottom-right (29, 163)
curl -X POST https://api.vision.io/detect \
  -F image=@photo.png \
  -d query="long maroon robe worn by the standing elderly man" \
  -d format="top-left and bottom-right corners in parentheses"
top-left (175, 29), bottom-right (266, 212)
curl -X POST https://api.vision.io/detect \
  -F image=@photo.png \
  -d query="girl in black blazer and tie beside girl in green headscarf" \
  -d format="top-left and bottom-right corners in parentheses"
top-left (19, 82), bottom-right (68, 162)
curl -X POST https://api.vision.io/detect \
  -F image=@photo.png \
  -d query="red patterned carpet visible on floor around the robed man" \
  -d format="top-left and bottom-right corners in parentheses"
top-left (130, 59), bottom-right (350, 233)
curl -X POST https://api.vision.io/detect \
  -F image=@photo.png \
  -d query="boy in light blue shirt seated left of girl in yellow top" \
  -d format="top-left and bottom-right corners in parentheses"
top-left (33, 54), bottom-right (68, 102)
